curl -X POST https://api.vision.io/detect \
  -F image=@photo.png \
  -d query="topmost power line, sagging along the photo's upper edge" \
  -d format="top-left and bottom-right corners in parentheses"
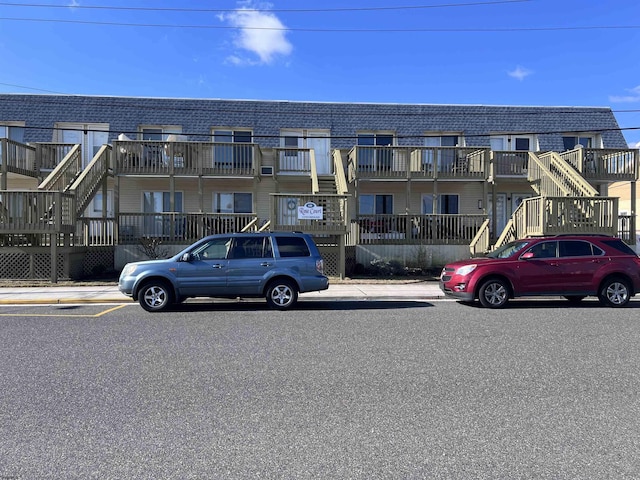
top-left (0, 0), bottom-right (531, 13)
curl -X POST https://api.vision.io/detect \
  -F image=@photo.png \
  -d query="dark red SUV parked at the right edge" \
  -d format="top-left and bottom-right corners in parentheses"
top-left (440, 235), bottom-right (640, 308)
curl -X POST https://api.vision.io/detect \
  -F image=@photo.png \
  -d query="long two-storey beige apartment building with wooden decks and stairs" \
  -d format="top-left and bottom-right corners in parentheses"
top-left (0, 94), bottom-right (638, 279)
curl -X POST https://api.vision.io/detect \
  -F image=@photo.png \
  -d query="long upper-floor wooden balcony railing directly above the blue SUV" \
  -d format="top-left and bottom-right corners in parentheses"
top-left (113, 141), bottom-right (261, 177)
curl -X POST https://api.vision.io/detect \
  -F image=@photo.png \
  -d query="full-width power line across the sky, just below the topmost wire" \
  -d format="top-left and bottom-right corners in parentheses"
top-left (0, 17), bottom-right (640, 33)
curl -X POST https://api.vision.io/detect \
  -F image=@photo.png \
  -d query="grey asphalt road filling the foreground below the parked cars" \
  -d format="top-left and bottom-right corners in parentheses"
top-left (0, 301), bottom-right (640, 480)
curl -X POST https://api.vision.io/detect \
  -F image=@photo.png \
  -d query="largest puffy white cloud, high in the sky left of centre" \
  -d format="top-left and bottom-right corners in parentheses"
top-left (218, 2), bottom-right (293, 65)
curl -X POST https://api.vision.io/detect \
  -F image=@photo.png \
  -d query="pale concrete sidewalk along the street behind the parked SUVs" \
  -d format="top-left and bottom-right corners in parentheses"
top-left (0, 281), bottom-right (444, 305)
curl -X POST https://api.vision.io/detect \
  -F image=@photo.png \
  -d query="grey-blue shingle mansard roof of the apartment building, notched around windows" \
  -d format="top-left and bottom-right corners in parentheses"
top-left (0, 94), bottom-right (627, 150)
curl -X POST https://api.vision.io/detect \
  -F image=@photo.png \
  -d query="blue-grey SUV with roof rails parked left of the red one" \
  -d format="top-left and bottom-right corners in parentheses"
top-left (118, 232), bottom-right (329, 312)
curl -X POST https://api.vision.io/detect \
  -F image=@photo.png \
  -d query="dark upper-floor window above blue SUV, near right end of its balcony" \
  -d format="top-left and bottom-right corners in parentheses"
top-left (212, 129), bottom-right (253, 169)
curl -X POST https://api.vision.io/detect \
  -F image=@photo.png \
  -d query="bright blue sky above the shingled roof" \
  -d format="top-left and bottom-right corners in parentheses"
top-left (0, 0), bottom-right (640, 148)
